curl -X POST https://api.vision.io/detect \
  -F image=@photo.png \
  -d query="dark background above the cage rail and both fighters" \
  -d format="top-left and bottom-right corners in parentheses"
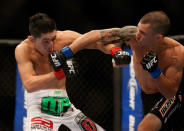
top-left (0, 0), bottom-right (184, 39)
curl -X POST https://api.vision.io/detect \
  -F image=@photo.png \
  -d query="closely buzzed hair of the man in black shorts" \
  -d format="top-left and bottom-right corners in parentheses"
top-left (140, 11), bottom-right (170, 35)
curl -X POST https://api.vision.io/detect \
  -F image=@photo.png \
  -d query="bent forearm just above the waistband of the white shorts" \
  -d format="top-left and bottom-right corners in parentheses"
top-left (23, 72), bottom-right (58, 92)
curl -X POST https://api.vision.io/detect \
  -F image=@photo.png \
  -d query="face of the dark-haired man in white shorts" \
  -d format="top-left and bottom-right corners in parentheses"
top-left (35, 30), bottom-right (56, 56)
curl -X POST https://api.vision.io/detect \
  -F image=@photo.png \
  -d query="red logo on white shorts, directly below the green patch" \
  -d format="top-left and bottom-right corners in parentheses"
top-left (31, 117), bottom-right (53, 131)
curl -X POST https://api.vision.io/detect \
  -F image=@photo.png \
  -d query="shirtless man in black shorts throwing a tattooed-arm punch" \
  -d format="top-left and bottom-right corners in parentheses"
top-left (57, 11), bottom-right (184, 131)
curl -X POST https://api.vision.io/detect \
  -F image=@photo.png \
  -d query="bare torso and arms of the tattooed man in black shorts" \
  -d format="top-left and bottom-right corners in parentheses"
top-left (68, 25), bottom-right (184, 98)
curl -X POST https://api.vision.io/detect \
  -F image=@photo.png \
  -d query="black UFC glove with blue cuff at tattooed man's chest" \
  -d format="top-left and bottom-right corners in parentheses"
top-left (141, 51), bottom-right (162, 78)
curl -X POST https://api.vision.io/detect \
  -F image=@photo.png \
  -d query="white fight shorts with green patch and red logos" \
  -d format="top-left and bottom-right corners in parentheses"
top-left (24, 90), bottom-right (104, 131)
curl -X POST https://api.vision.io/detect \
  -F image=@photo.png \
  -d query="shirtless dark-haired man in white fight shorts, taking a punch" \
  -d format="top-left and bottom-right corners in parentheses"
top-left (15, 13), bottom-right (130, 131)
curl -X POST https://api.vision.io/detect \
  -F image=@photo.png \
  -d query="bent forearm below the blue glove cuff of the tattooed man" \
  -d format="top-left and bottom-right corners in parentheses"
top-left (156, 74), bottom-right (178, 98)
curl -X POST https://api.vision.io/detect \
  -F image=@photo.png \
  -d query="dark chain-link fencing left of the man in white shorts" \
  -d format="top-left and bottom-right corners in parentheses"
top-left (0, 43), bottom-right (16, 131)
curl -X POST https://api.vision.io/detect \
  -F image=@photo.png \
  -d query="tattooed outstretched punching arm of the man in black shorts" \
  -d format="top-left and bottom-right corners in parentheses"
top-left (69, 26), bottom-right (137, 53)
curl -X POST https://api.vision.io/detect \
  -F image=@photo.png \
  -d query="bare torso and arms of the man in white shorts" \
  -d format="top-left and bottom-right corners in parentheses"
top-left (15, 31), bottom-right (115, 92)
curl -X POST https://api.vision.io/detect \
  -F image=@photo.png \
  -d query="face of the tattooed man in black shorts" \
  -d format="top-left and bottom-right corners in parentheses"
top-left (136, 22), bottom-right (156, 48)
